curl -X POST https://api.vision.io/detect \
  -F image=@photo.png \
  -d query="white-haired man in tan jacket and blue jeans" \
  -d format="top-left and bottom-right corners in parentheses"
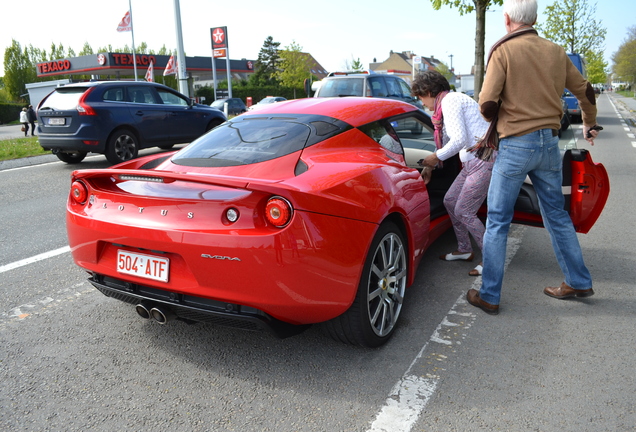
top-left (466, 0), bottom-right (598, 315)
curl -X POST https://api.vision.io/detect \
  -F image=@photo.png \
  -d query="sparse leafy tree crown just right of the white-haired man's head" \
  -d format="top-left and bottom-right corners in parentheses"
top-left (535, 0), bottom-right (607, 54)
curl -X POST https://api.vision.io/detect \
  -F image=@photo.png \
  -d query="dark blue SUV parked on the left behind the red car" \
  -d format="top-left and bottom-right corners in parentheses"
top-left (37, 81), bottom-right (227, 164)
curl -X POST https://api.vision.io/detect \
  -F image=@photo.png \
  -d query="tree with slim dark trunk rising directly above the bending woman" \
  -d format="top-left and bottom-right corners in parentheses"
top-left (431, 0), bottom-right (503, 100)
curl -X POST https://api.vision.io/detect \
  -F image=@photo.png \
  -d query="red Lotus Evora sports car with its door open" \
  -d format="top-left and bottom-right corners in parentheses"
top-left (67, 98), bottom-right (609, 347)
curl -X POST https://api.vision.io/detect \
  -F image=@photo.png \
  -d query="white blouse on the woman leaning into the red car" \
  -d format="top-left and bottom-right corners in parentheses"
top-left (435, 92), bottom-right (489, 162)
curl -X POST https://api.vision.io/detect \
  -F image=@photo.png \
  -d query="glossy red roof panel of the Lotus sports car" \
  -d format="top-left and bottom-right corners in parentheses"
top-left (243, 96), bottom-right (414, 127)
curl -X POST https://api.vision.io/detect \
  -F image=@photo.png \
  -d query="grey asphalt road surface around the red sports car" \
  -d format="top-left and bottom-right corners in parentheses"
top-left (0, 95), bottom-right (636, 432)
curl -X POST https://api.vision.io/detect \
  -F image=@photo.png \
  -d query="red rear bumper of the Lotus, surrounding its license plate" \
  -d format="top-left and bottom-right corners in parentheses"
top-left (67, 209), bottom-right (377, 325)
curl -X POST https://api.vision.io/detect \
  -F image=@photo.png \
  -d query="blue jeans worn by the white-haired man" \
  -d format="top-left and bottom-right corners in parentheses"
top-left (479, 129), bottom-right (592, 305)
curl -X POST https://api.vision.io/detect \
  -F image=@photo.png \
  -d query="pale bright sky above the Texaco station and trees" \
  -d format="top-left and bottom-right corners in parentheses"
top-left (0, 0), bottom-right (636, 76)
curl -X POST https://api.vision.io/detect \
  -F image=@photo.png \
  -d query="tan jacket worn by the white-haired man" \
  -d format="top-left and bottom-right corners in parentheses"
top-left (479, 34), bottom-right (596, 138)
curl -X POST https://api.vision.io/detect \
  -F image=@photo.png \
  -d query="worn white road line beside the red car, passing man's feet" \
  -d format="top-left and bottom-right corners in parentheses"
top-left (367, 225), bottom-right (526, 432)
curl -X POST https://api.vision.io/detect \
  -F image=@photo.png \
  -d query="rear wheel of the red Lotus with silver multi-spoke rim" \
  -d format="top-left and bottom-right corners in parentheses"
top-left (323, 222), bottom-right (408, 348)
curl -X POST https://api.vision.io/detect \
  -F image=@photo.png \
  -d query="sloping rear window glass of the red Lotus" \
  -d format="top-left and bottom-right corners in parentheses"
top-left (172, 118), bottom-right (311, 167)
